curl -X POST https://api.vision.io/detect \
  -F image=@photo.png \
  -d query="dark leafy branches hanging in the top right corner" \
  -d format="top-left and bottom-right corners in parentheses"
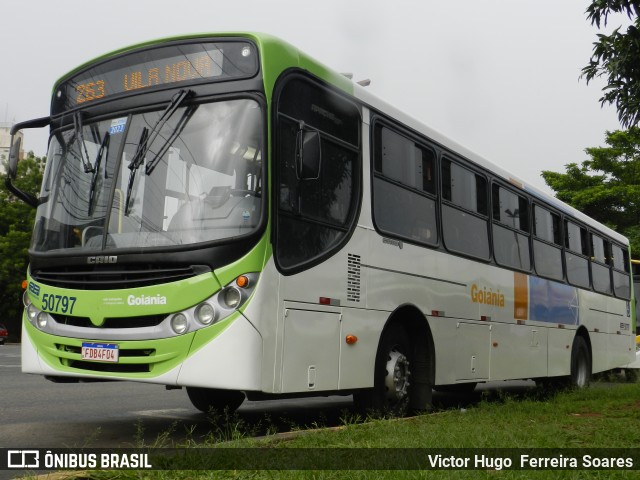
top-left (582, 0), bottom-right (640, 128)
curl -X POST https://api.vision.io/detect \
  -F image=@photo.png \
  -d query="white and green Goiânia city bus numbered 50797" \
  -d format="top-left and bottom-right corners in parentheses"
top-left (8, 33), bottom-right (635, 413)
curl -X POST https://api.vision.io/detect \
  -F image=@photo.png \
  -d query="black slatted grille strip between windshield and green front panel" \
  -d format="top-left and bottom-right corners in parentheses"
top-left (31, 265), bottom-right (211, 290)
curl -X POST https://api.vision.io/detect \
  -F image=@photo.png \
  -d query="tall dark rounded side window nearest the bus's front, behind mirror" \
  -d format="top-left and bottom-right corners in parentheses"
top-left (274, 74), bottom-right (361, 271)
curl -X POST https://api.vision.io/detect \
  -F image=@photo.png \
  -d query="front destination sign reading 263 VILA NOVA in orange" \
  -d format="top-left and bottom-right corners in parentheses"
top-left (52, 41), bottom-right (258, 115)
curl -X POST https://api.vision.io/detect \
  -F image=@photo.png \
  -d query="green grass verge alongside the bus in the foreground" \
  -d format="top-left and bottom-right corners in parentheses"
top-left (26, 383), bottom-right (640, 480)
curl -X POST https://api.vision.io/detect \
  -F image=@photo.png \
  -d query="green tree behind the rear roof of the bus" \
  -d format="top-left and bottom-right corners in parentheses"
top-left (542, 127), bottom-right (640, 257)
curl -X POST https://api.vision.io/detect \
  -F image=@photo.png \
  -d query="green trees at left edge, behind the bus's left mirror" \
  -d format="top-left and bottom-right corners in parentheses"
top-left (0, 152), bottom-right (45, 337)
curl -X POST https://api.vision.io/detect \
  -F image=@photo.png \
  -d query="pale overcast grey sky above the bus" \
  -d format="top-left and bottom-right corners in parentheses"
top-left (0, 0), bottom-right (625, 192)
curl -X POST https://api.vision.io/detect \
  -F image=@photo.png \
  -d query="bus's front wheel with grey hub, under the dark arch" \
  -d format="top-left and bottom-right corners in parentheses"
top-left (354, 324), bottom-right (413, 416)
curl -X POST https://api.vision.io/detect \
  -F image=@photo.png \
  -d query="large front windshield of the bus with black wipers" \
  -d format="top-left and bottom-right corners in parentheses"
top-left (32, 99), bottom-right (263, 252)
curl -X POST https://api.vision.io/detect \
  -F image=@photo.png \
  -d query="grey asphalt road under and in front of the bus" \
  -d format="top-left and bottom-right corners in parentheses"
top-left (0, 345), bottom-right (533, 448)
